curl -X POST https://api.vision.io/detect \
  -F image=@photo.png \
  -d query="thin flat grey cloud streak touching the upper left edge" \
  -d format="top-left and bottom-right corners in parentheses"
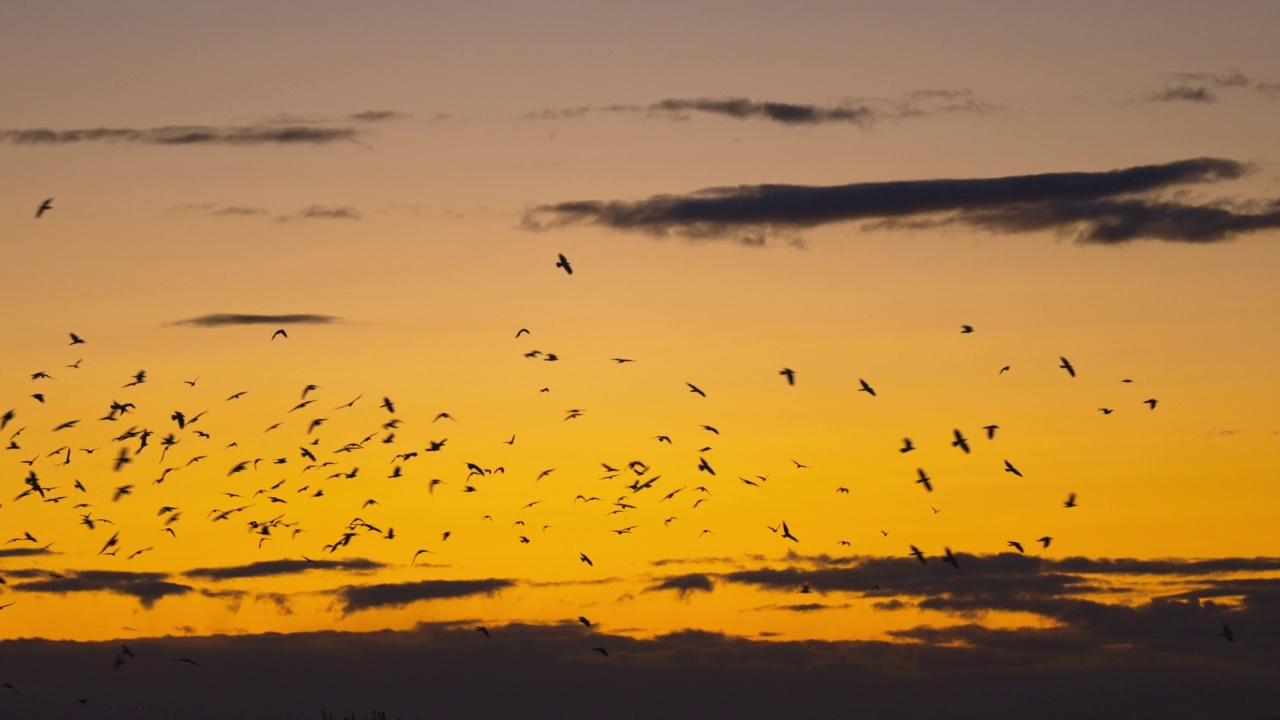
top-left (0, 126), bottom-right (358, 145)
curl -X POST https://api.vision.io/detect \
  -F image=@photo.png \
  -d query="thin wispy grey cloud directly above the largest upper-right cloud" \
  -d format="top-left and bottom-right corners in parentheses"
top-left (521, 90), bottom-right (1002, 128)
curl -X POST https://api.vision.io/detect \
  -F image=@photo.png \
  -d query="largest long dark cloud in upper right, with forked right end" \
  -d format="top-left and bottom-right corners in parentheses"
top-left (524, 158), bottom-right (1280, 245)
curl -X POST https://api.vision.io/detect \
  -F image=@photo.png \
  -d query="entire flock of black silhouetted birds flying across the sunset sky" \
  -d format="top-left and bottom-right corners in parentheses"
top-left (0, 199), bottom-right (1235, 707)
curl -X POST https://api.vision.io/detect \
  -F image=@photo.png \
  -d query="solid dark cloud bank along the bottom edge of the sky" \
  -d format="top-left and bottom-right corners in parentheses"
top-left (0, 624), bottom-right (1280, 720)
